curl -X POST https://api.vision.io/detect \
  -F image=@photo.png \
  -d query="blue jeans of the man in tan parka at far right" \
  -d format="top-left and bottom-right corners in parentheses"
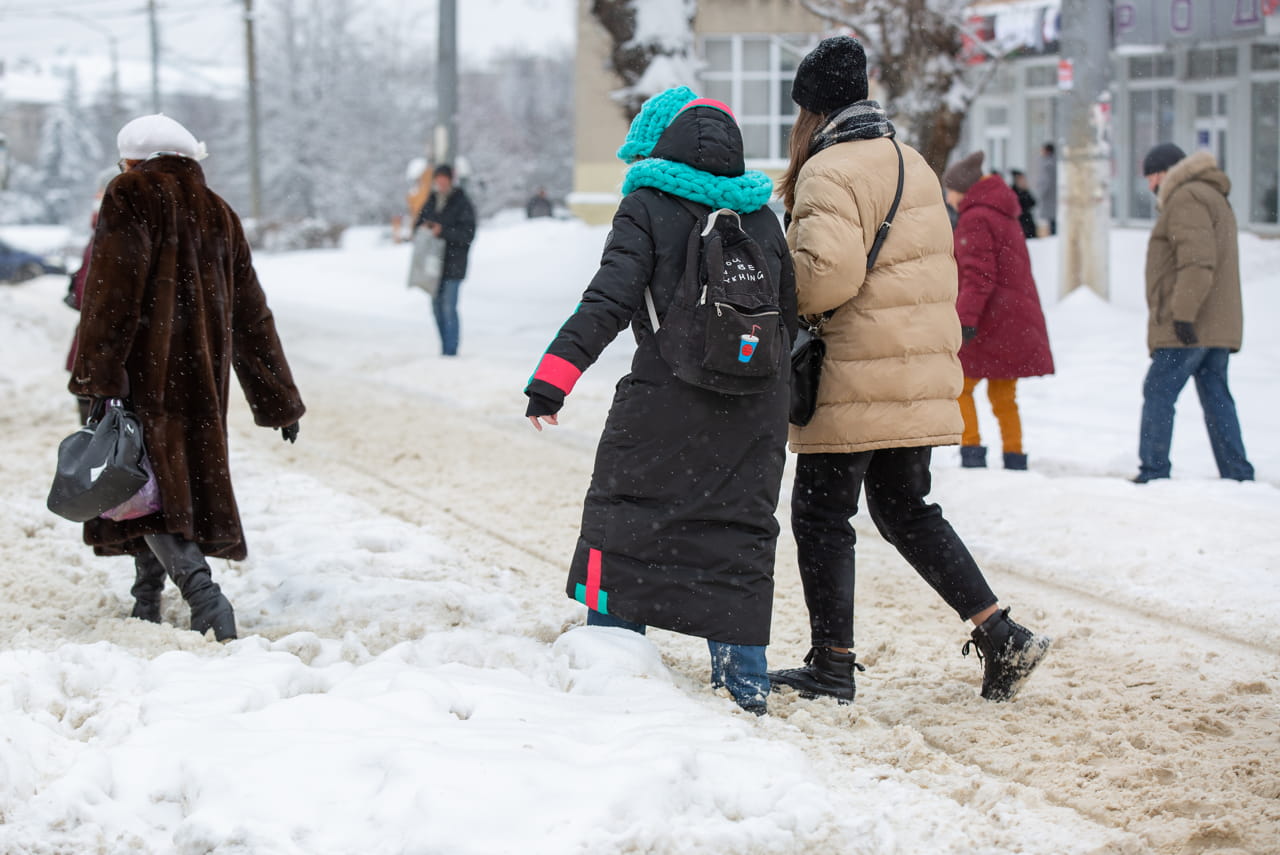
top-left (1138, 347), bottom-right (1253, 481)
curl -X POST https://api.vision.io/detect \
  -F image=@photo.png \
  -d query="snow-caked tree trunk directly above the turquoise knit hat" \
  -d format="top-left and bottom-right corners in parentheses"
top-left (591, 0), bottom-right (699, 120)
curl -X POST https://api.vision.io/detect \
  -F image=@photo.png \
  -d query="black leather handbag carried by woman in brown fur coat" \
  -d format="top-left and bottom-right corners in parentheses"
top-left (46, 398), bottom-right (154, 522)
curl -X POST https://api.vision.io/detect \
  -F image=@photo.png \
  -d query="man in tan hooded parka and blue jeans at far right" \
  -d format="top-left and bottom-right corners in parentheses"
top-left (1133, 142), bottom-right (1253, 484)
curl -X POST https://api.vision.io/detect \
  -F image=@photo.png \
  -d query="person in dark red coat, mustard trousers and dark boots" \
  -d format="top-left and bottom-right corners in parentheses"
top-left (942, 151), bottom-right (1053, 470)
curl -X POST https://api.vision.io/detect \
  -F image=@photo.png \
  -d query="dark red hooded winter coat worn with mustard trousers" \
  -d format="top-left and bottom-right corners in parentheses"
top-left (955, 175), bottom-right (1053, 379)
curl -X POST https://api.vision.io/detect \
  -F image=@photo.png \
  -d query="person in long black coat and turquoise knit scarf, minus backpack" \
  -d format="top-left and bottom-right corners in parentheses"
top-left (525, 87), bottom-right (796, 714)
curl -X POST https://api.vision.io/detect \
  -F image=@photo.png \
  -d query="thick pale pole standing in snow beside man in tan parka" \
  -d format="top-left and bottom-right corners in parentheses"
top-left (1057, 0), bottom-right (1112, 300)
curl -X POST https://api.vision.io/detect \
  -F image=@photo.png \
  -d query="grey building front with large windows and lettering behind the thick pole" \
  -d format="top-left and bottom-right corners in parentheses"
top-left (961, 0), bottom-right (1280, 234)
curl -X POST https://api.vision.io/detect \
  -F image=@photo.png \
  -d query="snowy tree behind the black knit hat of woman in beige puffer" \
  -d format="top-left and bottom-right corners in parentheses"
top-left (800, 0), bottom-right (996, 175)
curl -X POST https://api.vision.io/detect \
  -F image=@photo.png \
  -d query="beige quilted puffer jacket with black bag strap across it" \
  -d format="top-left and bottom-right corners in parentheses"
top-left (787, 138), bottom-right (964, 454)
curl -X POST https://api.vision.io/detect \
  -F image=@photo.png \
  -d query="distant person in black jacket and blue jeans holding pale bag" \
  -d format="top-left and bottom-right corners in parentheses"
top-left (411, 164), bottom-right (476, 356)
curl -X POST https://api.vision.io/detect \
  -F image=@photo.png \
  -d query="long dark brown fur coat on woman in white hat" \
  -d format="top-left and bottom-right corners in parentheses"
top-left (69, 156), bottom-right (303, 559)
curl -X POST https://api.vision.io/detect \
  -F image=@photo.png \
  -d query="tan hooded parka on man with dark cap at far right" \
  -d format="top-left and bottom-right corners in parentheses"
top-left (1152, 151), bottom-right (1244, 352)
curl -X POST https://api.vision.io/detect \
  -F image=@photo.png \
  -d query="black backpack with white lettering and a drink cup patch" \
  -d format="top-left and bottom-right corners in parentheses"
top-left (644, 198), bottom-right (790, 396)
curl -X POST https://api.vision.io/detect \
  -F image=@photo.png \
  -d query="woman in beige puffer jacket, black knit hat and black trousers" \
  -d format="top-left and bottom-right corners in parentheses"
top-left (769, 36), bottom-right (1050, 703)
